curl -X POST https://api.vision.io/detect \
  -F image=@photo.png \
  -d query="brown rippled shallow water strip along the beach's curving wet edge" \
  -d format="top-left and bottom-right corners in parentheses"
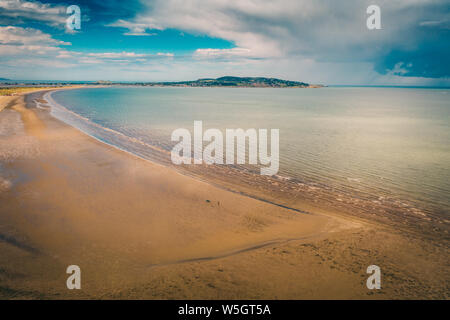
top-left (41, 85), bottom-right (450, 241)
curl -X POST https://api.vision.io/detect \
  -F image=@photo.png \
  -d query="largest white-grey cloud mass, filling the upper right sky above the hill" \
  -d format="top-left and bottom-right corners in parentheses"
top-left (104, 0), bottom-right (448, 82)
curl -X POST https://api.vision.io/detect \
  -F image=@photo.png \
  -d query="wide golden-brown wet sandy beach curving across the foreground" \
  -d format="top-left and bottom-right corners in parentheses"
top-left (0, 91), bottom-right (450, 299)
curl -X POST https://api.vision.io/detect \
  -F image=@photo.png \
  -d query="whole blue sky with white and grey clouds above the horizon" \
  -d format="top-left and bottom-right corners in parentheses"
top-left (0, 0), bottom-right (450, 86)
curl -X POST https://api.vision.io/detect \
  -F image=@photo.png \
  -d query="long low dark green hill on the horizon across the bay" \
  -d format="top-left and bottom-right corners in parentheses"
top-left (154, 76), bottom-right (320, 88)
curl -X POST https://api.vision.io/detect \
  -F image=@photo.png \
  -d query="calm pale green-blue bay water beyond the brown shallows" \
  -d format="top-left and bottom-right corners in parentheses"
top-left (52, 87), bottom-right (450, 218)
